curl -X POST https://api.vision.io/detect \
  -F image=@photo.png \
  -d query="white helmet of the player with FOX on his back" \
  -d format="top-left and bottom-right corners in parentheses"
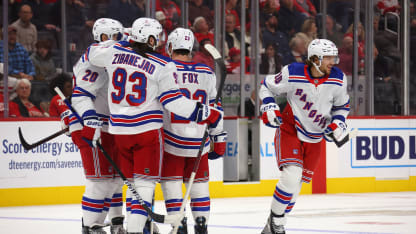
top-left (166, 28), bottom-right (195, 55)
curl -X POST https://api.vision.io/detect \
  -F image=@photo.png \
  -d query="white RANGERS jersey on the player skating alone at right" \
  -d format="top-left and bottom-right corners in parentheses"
top-left (259, 63), bottom-right (350, 143)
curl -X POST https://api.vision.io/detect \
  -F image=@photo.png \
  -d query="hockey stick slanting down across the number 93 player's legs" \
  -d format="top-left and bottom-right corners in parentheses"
top-left (55, 87), bottom-right (182, 224)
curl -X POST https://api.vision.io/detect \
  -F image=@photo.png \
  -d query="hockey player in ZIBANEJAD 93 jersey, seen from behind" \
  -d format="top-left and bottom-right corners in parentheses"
top-left (85, 18), bottom-right (222, 233)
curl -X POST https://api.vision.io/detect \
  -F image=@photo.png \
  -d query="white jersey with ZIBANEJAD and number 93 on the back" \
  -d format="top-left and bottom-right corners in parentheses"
top-left (86, 42), bottom-right (197, 135)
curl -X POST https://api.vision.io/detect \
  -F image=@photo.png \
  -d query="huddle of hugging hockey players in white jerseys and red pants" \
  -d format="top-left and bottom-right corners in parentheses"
top-left (52, 18), bottom-right (227, 234)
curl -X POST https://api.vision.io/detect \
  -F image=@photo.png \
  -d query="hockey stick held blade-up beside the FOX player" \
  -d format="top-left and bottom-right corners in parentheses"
top-left (172, 44), bottom-right (227, 234)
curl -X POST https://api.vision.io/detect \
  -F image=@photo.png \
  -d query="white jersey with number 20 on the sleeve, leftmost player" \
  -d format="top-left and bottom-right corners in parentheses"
top-left (71, 40), bottom-right (116, 132)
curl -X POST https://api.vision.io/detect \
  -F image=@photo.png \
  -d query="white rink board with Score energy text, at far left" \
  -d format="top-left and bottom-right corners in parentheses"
top-left (0, 121), bottom-right (84, 188)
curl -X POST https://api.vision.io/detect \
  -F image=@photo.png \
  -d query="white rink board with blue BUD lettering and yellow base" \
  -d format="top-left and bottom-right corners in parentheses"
top-left (326, 117), bottom-right (416, 192)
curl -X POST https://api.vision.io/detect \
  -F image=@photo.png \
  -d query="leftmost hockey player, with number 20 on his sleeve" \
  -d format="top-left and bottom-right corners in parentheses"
top-left (71, 18), bottom-right (126, 234)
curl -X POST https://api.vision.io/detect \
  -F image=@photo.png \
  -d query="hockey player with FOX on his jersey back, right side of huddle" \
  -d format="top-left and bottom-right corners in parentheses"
top-left (161, 28), bottom-right (227, 234)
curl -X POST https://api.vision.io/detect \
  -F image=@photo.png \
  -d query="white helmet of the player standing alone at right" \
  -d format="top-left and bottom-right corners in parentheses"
top-left (308, 39), bottom-right (339, 64)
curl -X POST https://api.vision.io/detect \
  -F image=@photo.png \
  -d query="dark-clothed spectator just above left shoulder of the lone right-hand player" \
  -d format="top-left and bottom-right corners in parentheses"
top-left (260, 44), bottom-right (282, 74)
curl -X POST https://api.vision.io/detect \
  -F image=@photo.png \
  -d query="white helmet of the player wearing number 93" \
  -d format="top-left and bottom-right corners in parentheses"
top-left (130, 17), bottom-right (163, 49)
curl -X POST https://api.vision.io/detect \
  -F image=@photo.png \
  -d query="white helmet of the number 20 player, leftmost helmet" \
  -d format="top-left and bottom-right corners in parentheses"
top-left (92, 18), bottom-right (123, 42)
